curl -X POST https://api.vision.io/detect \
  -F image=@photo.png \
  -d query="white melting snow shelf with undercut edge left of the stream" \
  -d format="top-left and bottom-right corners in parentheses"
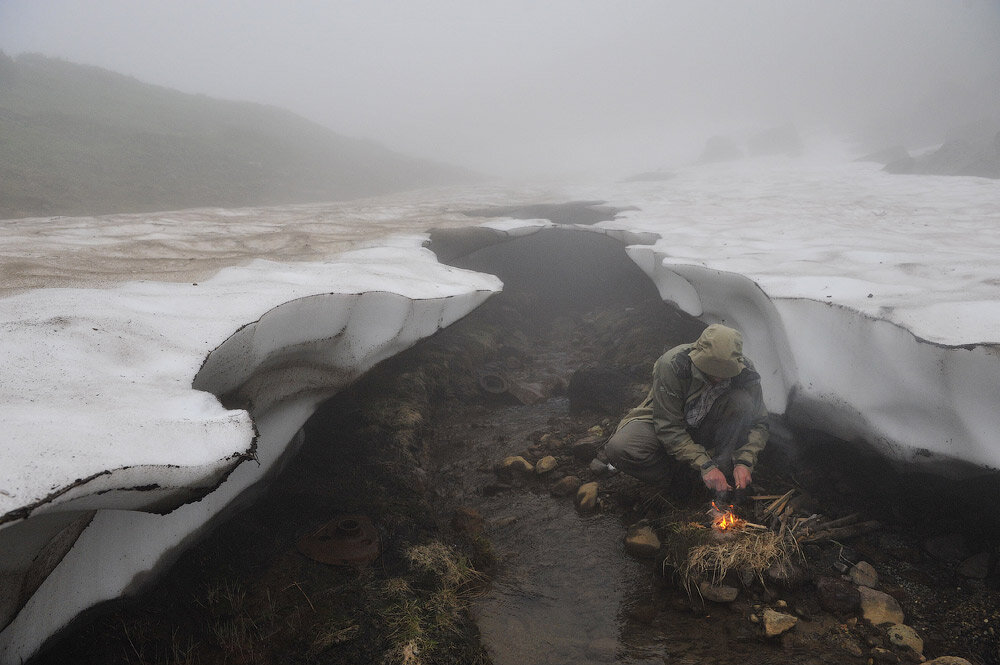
top-left (0, 245), bottom-right (501, 663)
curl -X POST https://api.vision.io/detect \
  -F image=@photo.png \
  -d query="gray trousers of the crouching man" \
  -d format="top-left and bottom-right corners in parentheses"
top-left (604, 389), bottom-right (754, 485)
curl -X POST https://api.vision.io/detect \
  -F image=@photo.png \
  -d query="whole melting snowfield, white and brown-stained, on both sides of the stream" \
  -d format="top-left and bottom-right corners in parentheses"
top-left (0, 152), bottom-right (1000, 663)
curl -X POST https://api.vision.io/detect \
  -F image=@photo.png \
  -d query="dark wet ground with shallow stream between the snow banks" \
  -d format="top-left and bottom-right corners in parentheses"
top-left (27, 228), bottom-right (1000, 665)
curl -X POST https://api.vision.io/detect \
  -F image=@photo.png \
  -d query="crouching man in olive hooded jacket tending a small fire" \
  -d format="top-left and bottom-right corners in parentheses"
top-left (591, 324), bottom-right (768, 494)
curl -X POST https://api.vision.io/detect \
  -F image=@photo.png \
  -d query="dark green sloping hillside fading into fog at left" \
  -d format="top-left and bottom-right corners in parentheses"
top-left (0, 52), bottom-right (474, 219)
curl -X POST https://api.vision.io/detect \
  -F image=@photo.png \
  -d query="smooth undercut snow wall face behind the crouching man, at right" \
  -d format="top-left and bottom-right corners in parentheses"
top-left (628, 247), bottom-right (1000, 473)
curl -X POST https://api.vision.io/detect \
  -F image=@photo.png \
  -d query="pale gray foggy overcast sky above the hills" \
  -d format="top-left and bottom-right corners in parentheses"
top-left (0, 0), bottom-right (1000, 175)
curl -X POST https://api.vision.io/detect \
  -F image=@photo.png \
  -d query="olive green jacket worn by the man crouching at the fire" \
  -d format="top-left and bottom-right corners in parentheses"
top-left (618, 344), bottom-right (768, 474)
